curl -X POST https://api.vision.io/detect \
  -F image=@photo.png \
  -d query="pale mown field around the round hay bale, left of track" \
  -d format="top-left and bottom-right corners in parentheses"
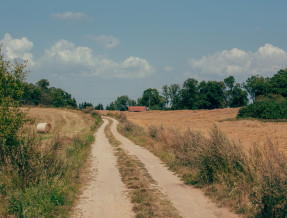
top-left (24, 107), bottom-right (94, 137)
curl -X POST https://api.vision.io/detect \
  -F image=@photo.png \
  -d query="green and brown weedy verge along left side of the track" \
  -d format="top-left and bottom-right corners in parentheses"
top-left (0, 112), bottom-right (103, 217)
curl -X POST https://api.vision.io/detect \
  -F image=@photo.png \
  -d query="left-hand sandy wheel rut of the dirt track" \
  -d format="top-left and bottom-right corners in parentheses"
top-left (72, 119), bottom-right (134, 218)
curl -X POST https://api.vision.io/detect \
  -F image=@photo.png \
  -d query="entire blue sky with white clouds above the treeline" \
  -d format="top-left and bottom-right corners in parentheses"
top-left (0, 0), bottom-right (287, 105)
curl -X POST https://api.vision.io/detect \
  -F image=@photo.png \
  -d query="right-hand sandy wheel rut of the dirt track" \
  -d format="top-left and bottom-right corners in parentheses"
top-left (111, 119), bottom-right (238, 218)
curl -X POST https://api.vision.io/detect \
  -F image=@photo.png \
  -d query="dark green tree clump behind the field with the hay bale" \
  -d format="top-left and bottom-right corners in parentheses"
top-left (22, 79), bottom-right (77, 108)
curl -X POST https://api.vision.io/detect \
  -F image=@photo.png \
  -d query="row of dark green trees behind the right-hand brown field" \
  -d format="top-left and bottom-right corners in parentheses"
top-left (106, 69), bottom-right (287, 111)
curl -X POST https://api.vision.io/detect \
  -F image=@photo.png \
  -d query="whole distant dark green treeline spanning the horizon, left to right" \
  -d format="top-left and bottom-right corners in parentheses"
top-left (22, 69), bottom-right (287, 113)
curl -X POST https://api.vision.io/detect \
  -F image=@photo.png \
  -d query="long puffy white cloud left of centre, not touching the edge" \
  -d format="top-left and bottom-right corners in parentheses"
top-left (37, 40), bottom-right (154, 78)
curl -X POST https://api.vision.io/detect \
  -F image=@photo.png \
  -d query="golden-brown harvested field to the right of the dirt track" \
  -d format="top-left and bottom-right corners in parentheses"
top-left (119, 108), bottom-right (287, 152)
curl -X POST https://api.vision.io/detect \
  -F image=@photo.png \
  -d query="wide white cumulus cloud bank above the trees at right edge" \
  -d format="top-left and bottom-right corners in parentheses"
top-left (187, 44), bottom-right (287, 79)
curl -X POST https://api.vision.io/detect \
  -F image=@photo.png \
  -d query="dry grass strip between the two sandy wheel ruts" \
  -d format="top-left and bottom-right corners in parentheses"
top-left (105, 118), bottom-right (180, 218)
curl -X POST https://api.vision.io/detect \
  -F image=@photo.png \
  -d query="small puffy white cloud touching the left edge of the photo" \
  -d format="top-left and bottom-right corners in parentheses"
top-left (0, 33), bottom-right (35, 66)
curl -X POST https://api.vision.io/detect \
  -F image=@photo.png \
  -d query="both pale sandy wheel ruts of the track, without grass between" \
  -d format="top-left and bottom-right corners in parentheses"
top-left (72, 118), bottom-right (238, 218)
